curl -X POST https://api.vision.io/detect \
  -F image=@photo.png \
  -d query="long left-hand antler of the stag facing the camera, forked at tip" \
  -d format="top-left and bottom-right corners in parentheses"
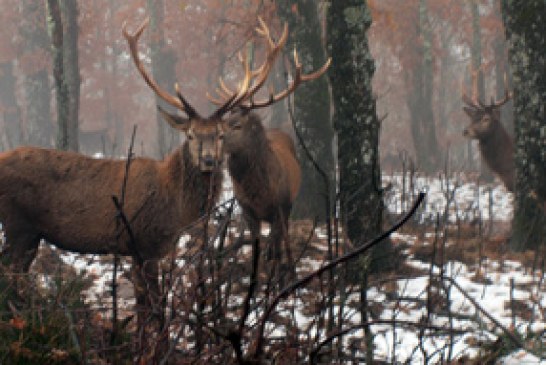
top-left (122, 18), bottom-right (199, 118)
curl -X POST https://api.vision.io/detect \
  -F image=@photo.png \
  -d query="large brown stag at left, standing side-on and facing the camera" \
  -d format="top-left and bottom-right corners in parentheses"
top-left (0, 21), bottom-right (262, 322)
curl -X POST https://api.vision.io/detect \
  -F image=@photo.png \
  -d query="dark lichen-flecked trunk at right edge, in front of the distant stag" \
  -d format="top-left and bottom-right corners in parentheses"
top-left (502, 0), bottom-right (546, 250)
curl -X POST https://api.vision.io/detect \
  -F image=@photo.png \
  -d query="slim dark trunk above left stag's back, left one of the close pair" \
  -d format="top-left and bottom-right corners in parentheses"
top-left (47, 0), bottom-right (69, 151)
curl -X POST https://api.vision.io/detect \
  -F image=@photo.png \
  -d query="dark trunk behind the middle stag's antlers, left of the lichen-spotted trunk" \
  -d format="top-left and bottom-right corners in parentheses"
top-left (277, 0), bottom-right (334, 219)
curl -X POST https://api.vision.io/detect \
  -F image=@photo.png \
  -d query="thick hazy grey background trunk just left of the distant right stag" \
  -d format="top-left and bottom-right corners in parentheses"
top-left (405, 0), bottom-right (442, 172)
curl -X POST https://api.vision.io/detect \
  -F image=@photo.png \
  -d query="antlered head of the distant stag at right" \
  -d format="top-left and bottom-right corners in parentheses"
top-left (462, 70), bottom-right (512, 141)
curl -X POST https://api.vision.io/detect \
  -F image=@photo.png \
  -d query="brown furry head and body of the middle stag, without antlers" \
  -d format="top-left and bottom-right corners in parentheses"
top-left (224, 109), bottom-right (301, 261)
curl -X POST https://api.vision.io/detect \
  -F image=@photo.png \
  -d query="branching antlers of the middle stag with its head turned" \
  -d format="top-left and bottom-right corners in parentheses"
top-left (207, 18), bottom-right (331, 115)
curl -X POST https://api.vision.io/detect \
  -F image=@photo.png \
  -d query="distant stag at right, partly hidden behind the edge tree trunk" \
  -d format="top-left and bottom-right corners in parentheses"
top-left (462, 72), bottom-right (515, 192)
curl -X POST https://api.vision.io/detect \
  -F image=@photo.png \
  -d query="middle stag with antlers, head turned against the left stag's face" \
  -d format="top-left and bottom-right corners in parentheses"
top-left (209, 19), bottom-right (330, 264)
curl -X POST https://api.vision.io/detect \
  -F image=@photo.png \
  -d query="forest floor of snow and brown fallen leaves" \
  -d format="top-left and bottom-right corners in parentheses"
top-left (20, 174), bottom-right (546, 364)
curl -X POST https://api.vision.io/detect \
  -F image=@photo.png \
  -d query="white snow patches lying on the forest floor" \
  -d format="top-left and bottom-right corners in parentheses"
top-left (47, 176), bottom-right (546, 364)
